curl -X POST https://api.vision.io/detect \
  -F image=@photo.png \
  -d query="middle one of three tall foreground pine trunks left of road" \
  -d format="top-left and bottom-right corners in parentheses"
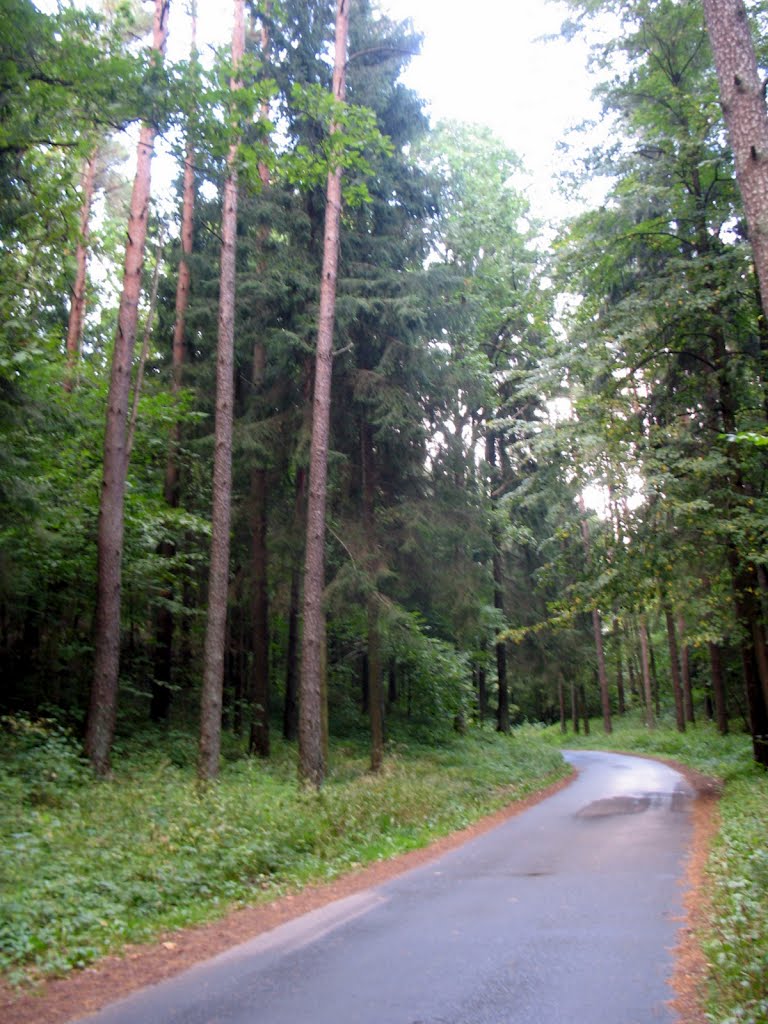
top-left (198, 0), bottom-right (245, 779)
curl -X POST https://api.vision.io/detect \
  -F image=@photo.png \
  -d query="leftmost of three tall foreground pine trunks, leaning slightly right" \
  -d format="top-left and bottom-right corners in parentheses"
top-left (85, 0), bottom-right (169, 774)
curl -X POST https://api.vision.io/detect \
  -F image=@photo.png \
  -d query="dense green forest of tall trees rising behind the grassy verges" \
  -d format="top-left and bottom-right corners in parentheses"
top-left (0, 0), bottom-right (768, 781)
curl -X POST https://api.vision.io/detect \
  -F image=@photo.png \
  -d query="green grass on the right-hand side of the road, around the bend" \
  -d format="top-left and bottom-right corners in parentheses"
top-left (534, 717), bottom-right (768, 1024)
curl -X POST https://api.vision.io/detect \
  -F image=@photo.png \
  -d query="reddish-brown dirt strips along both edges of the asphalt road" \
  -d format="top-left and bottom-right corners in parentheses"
top-left (0, 765), bottom-right (717, 1024)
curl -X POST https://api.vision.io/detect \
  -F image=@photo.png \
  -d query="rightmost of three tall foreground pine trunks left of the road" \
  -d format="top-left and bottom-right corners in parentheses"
top-left (299, 0), bottom-right (349, 788)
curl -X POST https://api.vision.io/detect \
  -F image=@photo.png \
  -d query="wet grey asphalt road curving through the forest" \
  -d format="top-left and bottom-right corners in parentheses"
top-left (75, 752), bottom-right (692, 1024)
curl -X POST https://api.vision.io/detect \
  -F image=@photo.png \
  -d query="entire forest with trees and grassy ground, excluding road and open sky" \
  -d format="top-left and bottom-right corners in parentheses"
top-left (0, 0), bottom-right (768, 1024)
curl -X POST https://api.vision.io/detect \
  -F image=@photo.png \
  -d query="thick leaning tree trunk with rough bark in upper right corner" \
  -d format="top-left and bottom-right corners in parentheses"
top-left (703, 0), bottom-right (768, 315)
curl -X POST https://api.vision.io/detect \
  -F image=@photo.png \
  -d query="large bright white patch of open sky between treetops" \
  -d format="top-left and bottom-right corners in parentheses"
top-left (382, 0), bottom-right (596, 215)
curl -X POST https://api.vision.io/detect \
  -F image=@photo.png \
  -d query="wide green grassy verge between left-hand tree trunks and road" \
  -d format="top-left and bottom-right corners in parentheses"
top-left (0, 719), bottom-right (566, 983)
